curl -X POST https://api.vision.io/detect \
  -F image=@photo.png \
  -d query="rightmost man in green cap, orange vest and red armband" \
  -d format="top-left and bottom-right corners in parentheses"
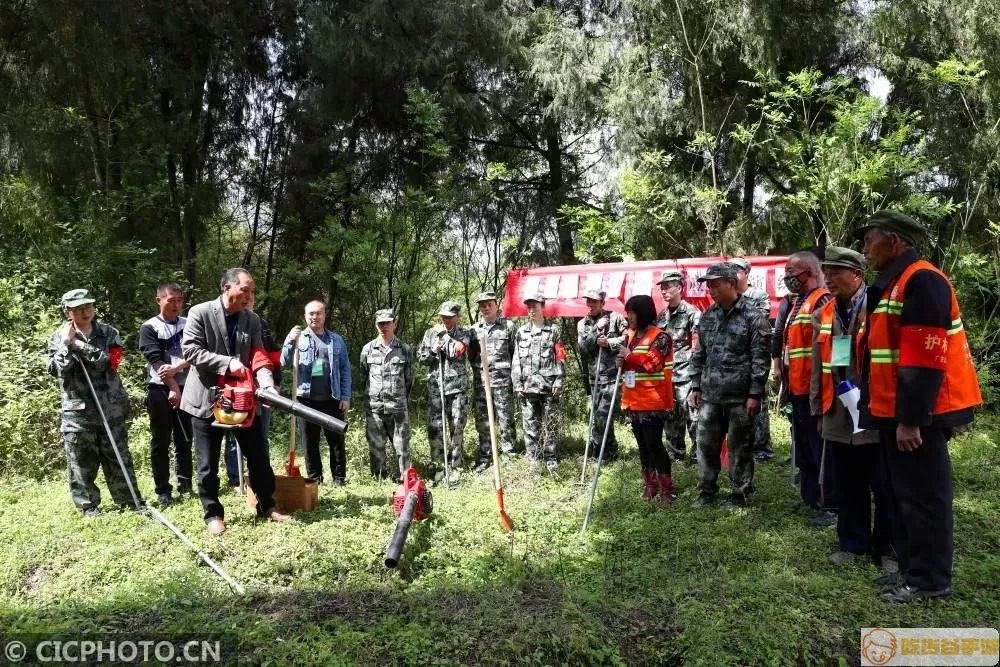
top-left (856, 211), bottom-right (982, 603)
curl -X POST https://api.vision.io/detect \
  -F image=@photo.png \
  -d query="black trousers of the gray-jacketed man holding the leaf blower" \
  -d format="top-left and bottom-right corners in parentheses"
top-left (191, 416), bottom-right (274, 522)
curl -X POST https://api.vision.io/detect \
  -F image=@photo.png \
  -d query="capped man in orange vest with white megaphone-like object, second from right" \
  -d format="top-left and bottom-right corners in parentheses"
top-left (809, 246), bottom-right (899, 573)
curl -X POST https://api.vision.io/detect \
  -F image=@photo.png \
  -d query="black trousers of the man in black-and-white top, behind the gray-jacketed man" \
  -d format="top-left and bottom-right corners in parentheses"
top-left (146, 384), bottom-right (193, 495)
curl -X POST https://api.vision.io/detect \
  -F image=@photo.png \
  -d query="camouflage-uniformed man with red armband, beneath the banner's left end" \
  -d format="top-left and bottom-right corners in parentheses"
top-left (511, 294), bottom-right (566, 472)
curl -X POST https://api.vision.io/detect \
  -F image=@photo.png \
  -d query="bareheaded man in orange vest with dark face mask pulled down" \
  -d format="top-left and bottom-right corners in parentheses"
top-left (782, 251), bottom-right (837, 526)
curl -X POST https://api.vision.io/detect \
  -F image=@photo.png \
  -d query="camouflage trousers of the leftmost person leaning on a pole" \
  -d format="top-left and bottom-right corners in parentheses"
top-left (62, 426), bottom-right (139, 511)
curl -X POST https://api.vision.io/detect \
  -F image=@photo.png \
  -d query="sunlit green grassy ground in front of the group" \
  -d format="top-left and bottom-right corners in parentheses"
top-left (0, 420), bottom-right (1000, 665)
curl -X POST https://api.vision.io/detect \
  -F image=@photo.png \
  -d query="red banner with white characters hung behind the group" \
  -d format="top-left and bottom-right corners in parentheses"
top-left (503, 257), bottom-right (788, 317)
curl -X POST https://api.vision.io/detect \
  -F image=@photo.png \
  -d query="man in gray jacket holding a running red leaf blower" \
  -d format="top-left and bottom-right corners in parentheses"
top-left (180, 268), bottom-right (290, 535)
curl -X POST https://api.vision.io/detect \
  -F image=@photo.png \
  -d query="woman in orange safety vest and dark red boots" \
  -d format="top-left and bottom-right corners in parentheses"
top-left (615, 294), bottom-right (674, 505)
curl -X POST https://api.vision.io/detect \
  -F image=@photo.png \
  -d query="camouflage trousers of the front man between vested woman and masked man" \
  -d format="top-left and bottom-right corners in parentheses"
top-left (698, 401), bottom-right (754, 499)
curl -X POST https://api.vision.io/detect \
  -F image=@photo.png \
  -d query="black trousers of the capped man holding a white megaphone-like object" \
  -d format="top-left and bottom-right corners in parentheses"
top-left (828, 441), bottom-right (895, 561)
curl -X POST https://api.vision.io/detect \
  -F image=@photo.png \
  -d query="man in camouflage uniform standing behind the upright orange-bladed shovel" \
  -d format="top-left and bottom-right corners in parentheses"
top-left (472, 292), bottom-right (517, 473)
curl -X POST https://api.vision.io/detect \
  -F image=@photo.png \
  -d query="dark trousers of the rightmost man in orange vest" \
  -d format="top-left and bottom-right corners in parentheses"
top-left (879, 427), bottom-right (954, 590)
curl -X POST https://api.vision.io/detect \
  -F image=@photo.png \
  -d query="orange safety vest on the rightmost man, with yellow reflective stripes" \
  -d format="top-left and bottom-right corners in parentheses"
top-left (855, 259), bottom-right (983, 419)
